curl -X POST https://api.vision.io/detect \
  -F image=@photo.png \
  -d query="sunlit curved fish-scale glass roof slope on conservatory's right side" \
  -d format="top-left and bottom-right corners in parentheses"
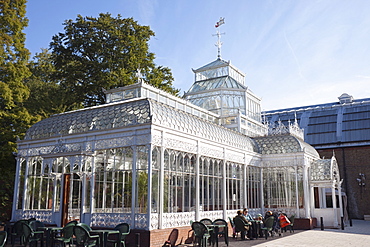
top-left (149, 100), bottom-right (258, 152)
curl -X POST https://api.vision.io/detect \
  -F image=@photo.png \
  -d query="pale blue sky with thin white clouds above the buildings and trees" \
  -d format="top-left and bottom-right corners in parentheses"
top-left (25, 0), bottom-right (370, 110)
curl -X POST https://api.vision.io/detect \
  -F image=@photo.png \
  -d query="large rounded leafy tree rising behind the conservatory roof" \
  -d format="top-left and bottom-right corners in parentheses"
top-left (50, 13), bottom-right (179, 106)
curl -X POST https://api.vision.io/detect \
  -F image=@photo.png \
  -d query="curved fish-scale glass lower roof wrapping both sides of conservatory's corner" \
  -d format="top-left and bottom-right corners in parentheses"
top-left (24, 99), bottom-right (258, 152)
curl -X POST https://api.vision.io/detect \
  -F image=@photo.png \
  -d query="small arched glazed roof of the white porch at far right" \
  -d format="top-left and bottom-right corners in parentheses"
top-left (310, 157), bottom-right (340, 183)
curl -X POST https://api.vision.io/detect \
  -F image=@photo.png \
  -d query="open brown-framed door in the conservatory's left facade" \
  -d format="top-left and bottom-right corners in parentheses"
top-left (61, 173), bottom-right (82, 226)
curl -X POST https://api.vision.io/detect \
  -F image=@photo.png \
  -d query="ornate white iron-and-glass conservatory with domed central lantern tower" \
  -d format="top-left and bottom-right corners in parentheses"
top-left (12, 59), bottom-right (340, 247)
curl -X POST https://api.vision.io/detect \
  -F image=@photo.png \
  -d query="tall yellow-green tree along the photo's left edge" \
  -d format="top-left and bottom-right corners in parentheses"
top-left (0, 0), bottom-right (37, 220)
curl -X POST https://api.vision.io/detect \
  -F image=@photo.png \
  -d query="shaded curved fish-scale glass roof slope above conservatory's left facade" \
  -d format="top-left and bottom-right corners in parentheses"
top-left (24, 99), bottom-right (151, 140)
